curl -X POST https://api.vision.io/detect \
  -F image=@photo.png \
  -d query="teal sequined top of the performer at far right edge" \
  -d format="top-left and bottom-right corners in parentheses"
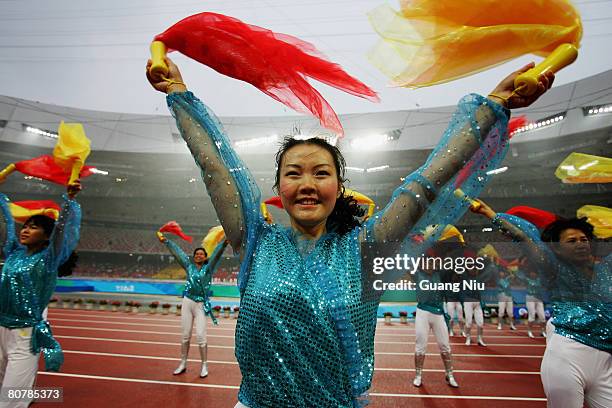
top-left (493, 214), bottom-right (612, 353)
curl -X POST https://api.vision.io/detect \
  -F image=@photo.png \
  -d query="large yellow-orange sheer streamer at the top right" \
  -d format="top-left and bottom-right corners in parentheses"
top-left (369, 0), bottom-right (582, 87)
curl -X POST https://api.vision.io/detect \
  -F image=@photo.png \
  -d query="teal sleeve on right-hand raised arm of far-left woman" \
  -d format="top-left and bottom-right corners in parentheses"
top-left (48, 194), bottom-right (81, 272)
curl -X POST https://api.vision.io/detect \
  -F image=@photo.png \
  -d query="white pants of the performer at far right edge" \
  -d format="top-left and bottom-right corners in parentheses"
top-left (540, 333), bottom-right (612, 408)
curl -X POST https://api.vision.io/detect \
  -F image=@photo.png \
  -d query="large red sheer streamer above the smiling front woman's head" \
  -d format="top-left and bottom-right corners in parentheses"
top-left (155, 13), bottom-right (378, 135)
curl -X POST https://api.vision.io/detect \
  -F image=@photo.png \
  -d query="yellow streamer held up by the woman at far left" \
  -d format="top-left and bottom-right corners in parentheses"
top-left (53, 121), bottom-right (91, 184)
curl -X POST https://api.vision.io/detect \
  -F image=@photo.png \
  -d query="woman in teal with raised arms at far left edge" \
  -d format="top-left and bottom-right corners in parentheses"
top-left (0, 179), bottom-right (81, 407)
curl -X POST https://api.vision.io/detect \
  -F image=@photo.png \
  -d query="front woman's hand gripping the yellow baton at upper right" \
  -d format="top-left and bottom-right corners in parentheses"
top-left (489, 62), bottom-right (555, 109)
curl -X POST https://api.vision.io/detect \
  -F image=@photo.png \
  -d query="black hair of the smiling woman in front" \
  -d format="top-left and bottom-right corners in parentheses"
top-left (274, 136), bottom-right (365, 235)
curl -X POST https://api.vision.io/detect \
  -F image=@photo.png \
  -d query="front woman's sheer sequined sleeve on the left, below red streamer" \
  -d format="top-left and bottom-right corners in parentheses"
top-left (167, 92), bottom-right (264, 291)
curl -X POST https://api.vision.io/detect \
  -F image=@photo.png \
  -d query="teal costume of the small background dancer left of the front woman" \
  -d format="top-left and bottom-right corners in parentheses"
top-left (164, 239), bottom-right (227, 324)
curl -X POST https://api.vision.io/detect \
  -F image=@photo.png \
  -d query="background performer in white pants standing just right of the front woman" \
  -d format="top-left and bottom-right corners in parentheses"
top-left (412, 271), bottom-right (459, 388)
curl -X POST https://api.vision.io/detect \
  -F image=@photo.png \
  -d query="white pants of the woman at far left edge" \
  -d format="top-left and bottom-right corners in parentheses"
top-left (0, 327), bottom-right (38, 408)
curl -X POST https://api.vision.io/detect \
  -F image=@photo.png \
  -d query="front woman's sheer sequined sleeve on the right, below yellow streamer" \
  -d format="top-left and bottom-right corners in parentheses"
top-left (360, 94), bottom-right (509, 274)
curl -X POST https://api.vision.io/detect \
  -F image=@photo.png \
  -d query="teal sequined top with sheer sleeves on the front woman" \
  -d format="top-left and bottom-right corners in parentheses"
top-left (167, 92), bottom-right (508, 408)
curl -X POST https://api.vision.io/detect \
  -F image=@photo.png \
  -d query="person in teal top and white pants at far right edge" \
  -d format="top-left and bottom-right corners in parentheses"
top-left (472, 202), bottom-right (612, 408)
